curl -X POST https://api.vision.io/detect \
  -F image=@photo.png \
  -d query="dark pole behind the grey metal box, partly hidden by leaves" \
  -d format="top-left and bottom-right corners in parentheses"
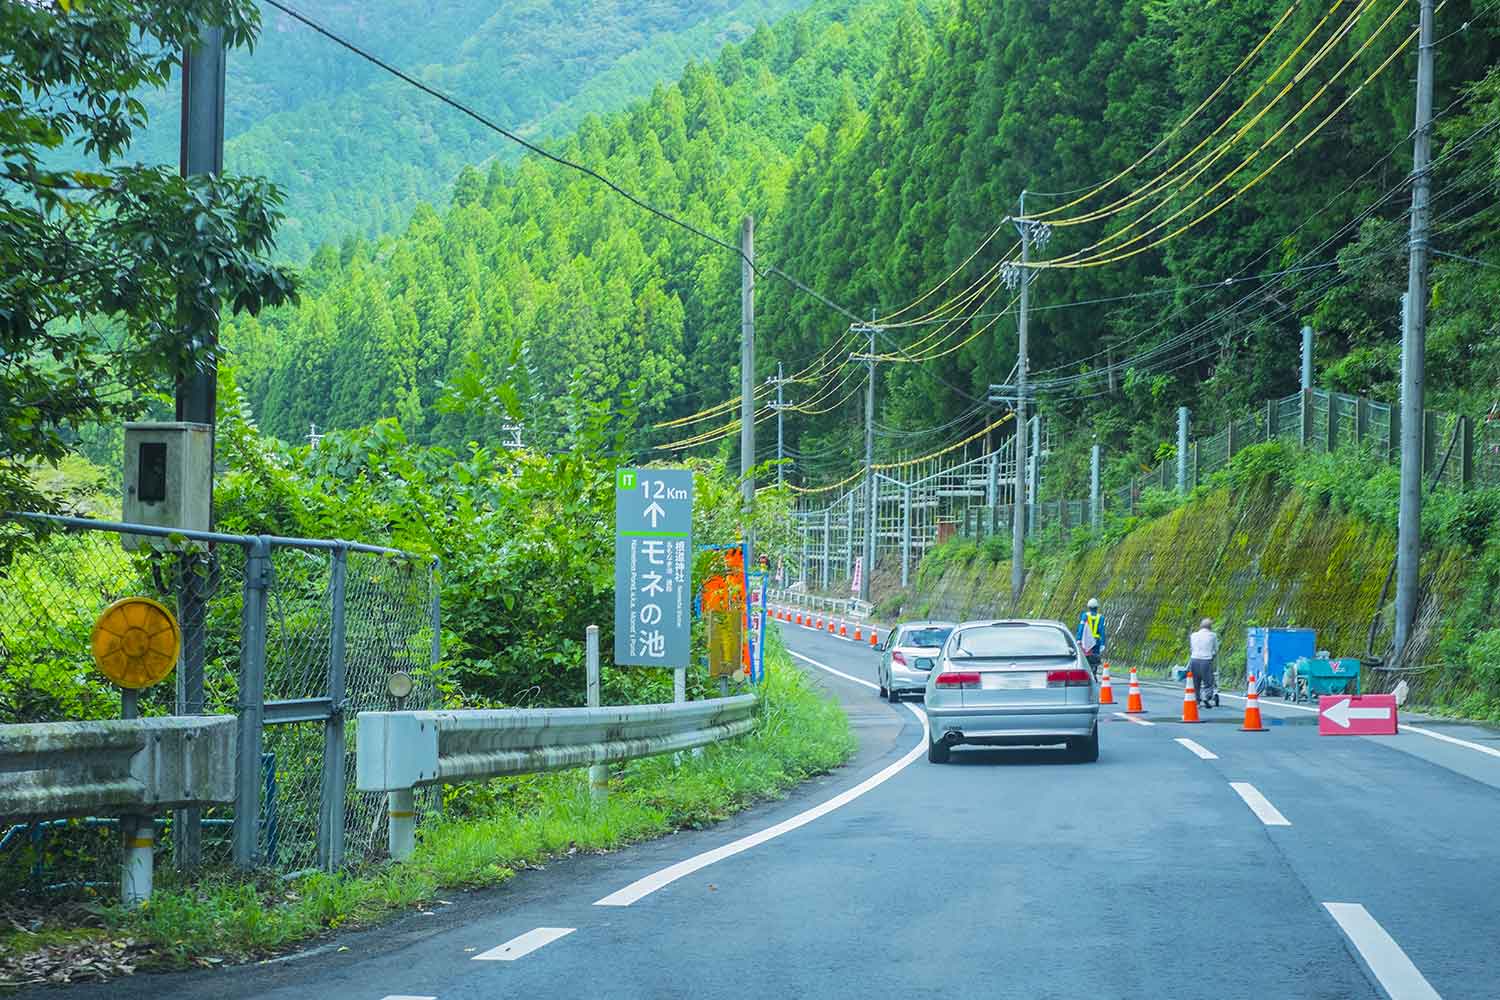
top-left (173, 21), bottom-right (225, 868)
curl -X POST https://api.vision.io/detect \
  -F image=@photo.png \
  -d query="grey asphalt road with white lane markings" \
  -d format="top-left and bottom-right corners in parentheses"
top-left (44, 627), bottom-right (1500, 1000)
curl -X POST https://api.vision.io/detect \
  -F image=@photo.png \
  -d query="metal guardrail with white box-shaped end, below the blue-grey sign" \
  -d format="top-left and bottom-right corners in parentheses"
top-left (356, 694), bottom-right (755, 861)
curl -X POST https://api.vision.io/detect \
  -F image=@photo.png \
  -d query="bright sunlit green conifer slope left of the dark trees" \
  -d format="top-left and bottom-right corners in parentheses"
top-left (224, 0), bottom-right (924, 445)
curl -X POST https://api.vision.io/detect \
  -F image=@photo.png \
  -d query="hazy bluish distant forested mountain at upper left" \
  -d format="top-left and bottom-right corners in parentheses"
top-left (90, 0), bottom-right (807, 259)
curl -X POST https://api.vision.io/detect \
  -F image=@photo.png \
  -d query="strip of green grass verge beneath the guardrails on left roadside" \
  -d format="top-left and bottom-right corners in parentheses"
top-left (0, 639), bottom-right (855, 987)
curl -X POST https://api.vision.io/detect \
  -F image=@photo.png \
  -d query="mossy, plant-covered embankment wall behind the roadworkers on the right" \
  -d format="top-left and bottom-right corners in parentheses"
top-left (881, 444), bottom-right (1500, 718)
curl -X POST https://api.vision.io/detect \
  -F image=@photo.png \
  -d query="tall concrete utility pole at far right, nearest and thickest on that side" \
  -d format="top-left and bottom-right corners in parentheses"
top-left (1395, 0), bottom-right (1433, 657)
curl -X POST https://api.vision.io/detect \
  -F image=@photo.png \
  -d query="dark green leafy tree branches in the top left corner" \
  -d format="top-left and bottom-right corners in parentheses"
top-left (0, 0), bottom-right (294, 508)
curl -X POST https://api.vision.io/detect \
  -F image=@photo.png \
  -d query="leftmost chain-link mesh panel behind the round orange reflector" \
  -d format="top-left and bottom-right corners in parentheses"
top-left (0, 519), bottom-right (245, 892)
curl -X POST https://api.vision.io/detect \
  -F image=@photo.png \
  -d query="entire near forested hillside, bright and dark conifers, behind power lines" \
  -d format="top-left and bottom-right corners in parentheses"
top-left (230, 0), bottom-right (1500, 493)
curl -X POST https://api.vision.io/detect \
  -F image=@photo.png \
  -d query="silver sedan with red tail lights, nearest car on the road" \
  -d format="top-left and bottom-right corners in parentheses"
top-left (926, 621), bottom-right (1100, 763)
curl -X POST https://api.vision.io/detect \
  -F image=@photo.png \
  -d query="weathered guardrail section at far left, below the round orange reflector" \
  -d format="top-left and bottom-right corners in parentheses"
top-left (0, 715), bottom-right (239, 904)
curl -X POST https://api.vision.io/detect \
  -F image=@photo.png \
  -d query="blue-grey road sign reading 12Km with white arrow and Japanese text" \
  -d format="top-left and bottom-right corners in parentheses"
top-left (615, 469), bottom-right (693, 667)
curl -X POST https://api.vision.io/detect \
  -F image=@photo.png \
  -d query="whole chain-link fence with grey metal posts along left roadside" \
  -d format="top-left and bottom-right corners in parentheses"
top-left (0, 517), bottom-right (441, 889)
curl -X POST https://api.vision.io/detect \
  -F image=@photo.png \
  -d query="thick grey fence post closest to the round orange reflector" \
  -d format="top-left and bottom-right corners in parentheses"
top-left (234, 535), bottom-right (272, 868)
